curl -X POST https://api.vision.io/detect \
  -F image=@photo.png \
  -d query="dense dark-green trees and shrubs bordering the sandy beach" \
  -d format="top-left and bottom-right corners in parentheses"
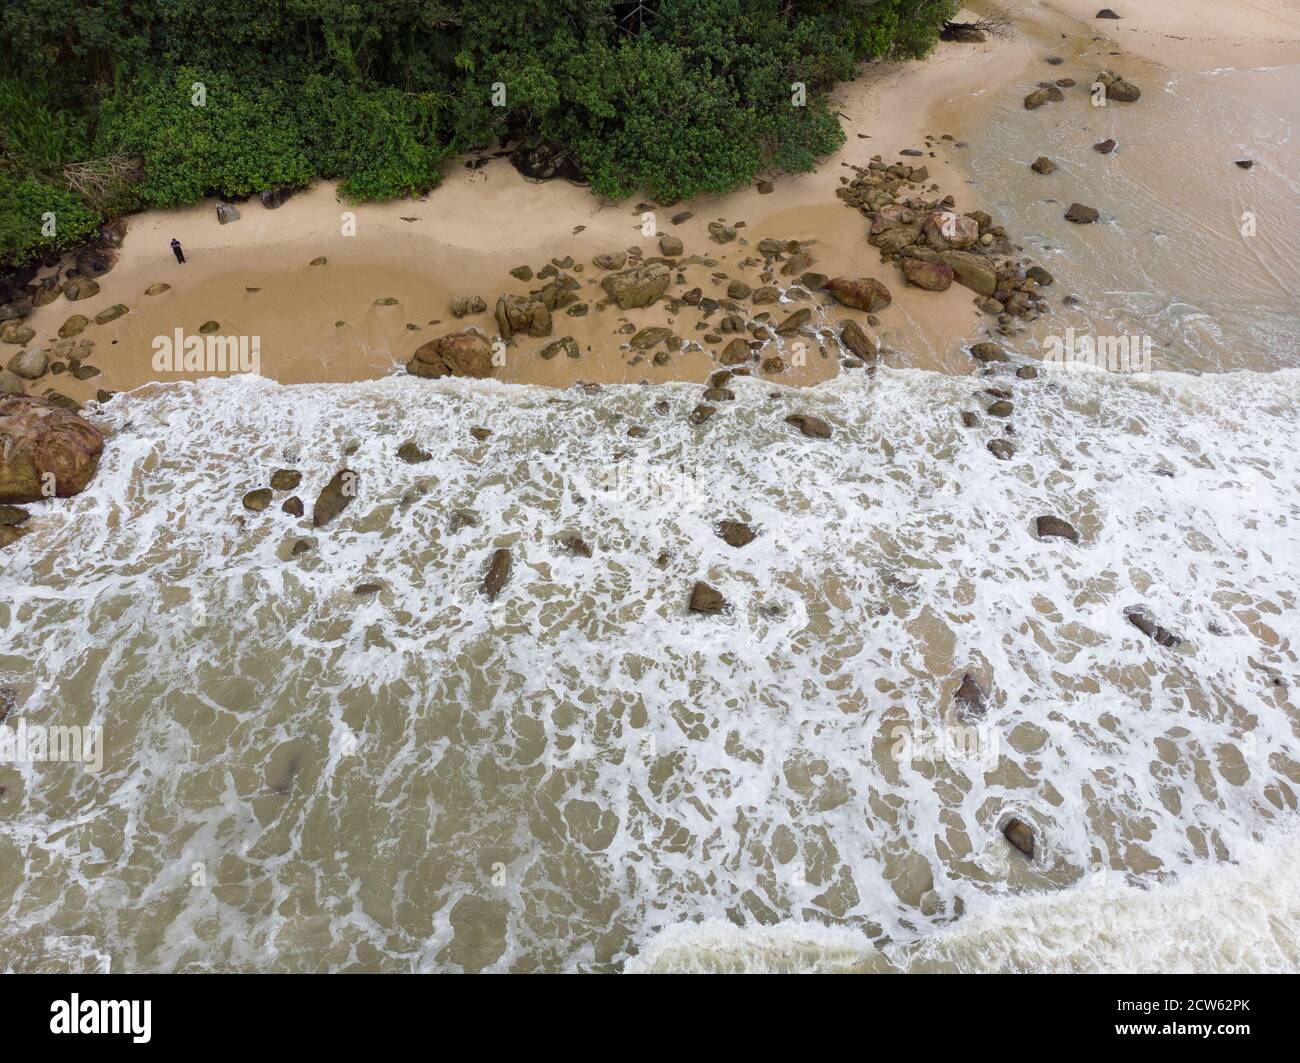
top-left (0, 0), bottom-right (956, 260)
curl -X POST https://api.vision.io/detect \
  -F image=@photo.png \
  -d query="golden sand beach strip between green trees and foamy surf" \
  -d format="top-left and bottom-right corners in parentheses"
top-left (3, 0), bottom-right (1300, 403)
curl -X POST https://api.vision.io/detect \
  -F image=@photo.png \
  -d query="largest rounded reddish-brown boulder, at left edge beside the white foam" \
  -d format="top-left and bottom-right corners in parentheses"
top-left (0, 395), bottom-right (104, 502)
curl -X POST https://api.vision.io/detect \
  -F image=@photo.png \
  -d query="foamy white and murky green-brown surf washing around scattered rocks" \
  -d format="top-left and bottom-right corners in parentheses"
top-left (0, 358), bottom-right (1300, 971)
